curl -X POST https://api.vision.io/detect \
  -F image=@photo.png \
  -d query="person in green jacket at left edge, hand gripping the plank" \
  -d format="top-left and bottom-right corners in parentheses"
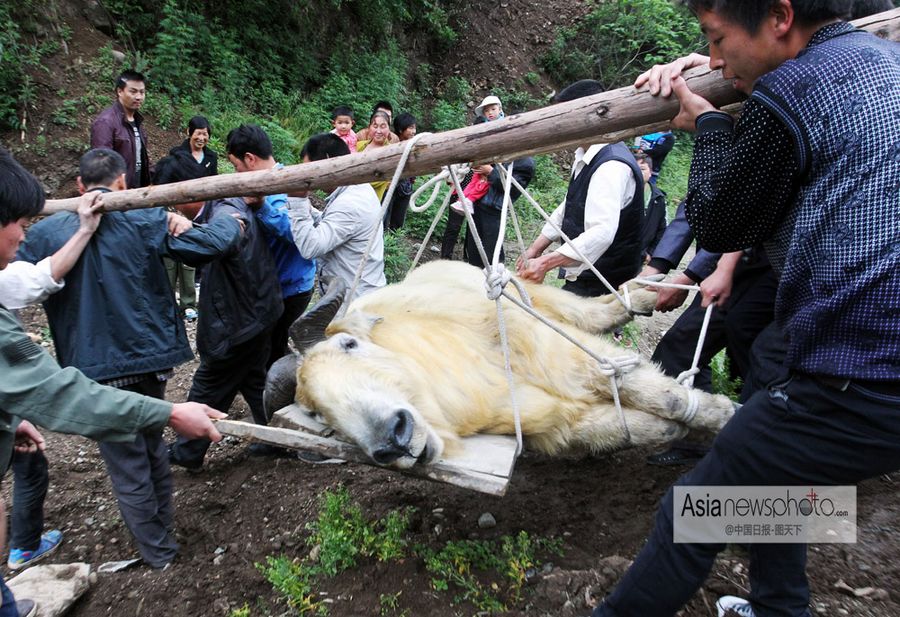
top-left (0, 148), bottom-right (225, 606)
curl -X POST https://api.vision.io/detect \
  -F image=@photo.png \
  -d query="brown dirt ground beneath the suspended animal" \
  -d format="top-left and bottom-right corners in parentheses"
top-left (4, 310), bottom-right (900, 617)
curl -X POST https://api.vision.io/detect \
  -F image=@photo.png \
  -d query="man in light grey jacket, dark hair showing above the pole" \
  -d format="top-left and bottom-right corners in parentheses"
top-left (289, 133), bottom-right (386, 297)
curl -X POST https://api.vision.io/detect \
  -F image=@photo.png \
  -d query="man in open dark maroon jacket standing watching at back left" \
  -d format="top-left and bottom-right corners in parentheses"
top-left (91, 71), bottom-right (150, 189)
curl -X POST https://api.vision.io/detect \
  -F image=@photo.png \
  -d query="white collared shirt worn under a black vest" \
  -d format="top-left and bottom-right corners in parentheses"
top-left (541, 144), bottom-right (635, 280)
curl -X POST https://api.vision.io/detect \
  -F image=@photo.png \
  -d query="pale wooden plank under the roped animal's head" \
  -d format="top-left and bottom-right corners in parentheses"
top-left (216, 405), bottom-right (516, 497)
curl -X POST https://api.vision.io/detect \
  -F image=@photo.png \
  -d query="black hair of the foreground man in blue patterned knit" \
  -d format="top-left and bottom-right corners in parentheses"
top-left (684, 0), bottom-right (852, 34)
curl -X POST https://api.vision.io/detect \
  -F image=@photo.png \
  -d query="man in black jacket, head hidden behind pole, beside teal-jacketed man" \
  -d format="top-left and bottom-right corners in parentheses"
top-left (170, 192), bottom-right (283, 469)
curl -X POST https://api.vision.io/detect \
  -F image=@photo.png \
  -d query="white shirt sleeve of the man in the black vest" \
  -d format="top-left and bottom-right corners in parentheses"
top-left (559, 161), bottom-right (635, 263)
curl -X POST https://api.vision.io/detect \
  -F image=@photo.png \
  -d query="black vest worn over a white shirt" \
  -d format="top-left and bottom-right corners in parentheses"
top-left (562, 142), bottom-right (644, 295)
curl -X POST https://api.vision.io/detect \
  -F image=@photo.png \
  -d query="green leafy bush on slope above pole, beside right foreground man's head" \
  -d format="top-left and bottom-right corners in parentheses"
top-left (541, 0), bottom-right (704, 88)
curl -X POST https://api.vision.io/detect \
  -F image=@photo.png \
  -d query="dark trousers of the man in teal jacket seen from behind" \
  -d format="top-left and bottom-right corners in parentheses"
top-left (99, 375), bottom-right (178, 568)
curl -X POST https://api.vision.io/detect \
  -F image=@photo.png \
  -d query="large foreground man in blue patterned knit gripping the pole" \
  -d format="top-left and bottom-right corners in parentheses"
top-left (594, 0), bottom-right (900, 617)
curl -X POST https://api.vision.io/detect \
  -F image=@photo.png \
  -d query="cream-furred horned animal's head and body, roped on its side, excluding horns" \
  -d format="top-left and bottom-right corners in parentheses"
top-left (297, 261), bottom-right (734, 468)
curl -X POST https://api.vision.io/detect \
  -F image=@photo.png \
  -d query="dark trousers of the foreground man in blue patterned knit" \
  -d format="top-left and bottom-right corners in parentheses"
top-left (593, 373), bottom-right (900, 617)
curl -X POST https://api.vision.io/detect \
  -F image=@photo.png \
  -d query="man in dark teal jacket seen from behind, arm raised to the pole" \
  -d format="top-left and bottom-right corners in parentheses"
top-left (18, 149), bottom-right (241, 568)
